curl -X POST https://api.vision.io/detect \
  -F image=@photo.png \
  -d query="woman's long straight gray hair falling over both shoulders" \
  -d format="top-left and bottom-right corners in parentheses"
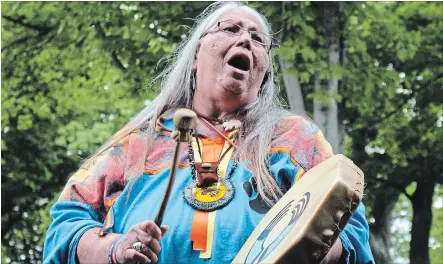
top-left (84, 2), bottom-right (288, 205)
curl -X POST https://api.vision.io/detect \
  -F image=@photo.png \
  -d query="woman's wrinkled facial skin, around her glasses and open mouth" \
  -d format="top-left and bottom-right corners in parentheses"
top-left (193, 8), bottom-right (269, 118)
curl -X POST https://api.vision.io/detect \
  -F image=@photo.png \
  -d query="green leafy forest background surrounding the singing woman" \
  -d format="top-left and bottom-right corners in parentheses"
top-left (1, 2), bottom-right (443, 264)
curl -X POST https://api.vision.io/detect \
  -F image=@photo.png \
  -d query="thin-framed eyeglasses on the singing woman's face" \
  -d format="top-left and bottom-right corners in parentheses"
top-left (217, 21), bottom-right (273, 52)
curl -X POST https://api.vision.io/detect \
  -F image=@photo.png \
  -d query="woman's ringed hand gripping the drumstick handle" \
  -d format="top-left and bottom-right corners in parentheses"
top-left (115, 220), bottom-right (168, 264)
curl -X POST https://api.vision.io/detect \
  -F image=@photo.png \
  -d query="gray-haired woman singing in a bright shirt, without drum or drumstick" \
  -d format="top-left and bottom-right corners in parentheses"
top-left (44, 3), bottom-right (373, 263)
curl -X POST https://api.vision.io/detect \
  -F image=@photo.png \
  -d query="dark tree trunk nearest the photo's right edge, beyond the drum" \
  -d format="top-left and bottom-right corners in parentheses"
top-left (409, 177), bottom-right (435, 264)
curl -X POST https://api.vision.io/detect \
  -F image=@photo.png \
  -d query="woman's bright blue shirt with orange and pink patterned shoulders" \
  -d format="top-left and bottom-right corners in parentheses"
top-left (44, 116), bottom-right (374, 264)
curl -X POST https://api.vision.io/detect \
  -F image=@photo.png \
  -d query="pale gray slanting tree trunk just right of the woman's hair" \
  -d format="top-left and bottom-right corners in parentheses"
top-left (278, 56), bottom-right (306, 116)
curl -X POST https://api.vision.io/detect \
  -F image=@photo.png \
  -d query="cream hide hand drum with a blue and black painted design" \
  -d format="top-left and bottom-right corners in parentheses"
top-left (233, 154), bottom-right (364, 264)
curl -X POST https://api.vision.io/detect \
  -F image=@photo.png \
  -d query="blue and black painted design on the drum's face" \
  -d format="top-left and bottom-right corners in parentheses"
top-left (245, 192), bottom-right (311, 263)
